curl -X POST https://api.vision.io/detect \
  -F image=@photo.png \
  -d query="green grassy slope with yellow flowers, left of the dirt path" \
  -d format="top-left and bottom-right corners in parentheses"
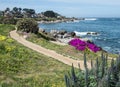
top-left (0, 25), bottom-right (70, 87)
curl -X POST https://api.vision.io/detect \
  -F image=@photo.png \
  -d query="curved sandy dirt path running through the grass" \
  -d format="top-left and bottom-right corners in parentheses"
top-left (10, 30), bottom-right (91, 70)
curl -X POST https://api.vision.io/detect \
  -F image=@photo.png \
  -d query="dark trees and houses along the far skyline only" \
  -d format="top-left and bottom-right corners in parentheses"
top-left (0, 7), bottom-right (61, 18)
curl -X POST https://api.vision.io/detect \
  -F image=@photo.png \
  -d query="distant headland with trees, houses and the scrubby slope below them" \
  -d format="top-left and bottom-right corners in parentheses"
top-left (0, 7), bottom-right (63, 24)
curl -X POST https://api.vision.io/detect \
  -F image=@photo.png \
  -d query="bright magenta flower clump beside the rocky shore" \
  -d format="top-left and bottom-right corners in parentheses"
top-left (69, 38), bottom-right (100, 52)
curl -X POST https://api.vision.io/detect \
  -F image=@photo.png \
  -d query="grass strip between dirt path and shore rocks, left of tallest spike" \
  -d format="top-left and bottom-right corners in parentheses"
top-left (27, 35), bottom-right (82, 59)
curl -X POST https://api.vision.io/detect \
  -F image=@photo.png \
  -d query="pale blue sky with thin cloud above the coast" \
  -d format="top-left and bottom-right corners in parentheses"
top-left (0, 0), bottom-right (120, 17)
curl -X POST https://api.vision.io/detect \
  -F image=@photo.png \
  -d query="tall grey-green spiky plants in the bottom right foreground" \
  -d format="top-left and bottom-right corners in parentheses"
top-left (65, 53), bottom-right (120, 87)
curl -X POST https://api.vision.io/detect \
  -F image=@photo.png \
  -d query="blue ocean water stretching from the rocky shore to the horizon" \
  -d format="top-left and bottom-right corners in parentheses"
top-left (39, 18), bottom-right (120, 54)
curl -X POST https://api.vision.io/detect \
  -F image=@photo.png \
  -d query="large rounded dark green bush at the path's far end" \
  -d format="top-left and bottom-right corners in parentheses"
top-left (17, 19), bottom-right (39, 34)
